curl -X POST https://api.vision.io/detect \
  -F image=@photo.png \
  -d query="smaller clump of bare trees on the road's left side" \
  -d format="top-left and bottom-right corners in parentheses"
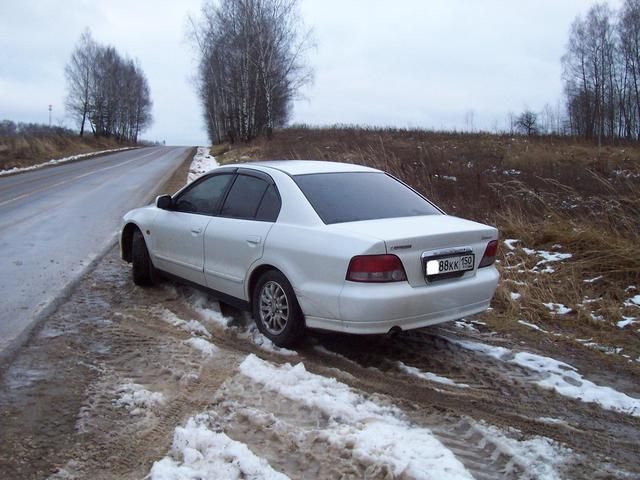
top-left (65, 30), bottom-right (152, 142)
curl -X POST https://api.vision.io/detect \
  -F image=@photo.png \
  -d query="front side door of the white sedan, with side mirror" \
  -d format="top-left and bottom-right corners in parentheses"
top-left (150, 172), bottom-right (234, 285)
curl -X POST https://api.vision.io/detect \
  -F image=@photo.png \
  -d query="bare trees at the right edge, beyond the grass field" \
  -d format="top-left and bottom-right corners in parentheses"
top-left (562, 0), bottom-right (640, 142)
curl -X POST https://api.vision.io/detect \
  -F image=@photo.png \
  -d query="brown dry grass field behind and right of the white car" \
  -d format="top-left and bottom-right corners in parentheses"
top-left (218, 128), bottom-right (640, 371)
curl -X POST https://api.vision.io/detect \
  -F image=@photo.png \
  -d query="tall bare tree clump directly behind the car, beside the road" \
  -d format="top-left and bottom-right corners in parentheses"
top-left (192, 0), bottom-right (311, 143)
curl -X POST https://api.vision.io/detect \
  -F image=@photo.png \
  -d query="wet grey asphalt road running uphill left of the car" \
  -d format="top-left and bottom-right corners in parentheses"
top-left (0, 147), bottom-right (189, 358)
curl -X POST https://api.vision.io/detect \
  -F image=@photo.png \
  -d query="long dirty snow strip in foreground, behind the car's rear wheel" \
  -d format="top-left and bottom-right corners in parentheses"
top-left (240, 355), bottom-right (473, 479)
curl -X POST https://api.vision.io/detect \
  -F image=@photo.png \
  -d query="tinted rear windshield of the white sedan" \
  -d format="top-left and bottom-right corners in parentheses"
top-left (293, 172), bottom-right (440, 224)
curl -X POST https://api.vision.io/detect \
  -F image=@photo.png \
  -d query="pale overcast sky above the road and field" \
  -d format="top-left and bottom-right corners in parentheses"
top-left (0, 0), bottom-right (622, 144)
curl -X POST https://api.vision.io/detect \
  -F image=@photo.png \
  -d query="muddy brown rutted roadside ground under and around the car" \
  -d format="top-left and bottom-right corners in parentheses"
top-left (0, 244), bottom-right (640, 479)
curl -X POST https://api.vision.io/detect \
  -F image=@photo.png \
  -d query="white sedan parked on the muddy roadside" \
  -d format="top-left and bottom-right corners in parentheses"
top-left (120, 161), bottom-right (498, 346)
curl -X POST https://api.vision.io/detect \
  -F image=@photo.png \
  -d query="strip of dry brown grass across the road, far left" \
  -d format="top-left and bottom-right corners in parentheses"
top-left (0, 135), bottom-right (129, 170)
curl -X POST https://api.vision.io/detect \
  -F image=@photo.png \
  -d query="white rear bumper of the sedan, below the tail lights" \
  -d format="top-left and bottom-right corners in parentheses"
top-left (306, 267), bottom-right (499, 334)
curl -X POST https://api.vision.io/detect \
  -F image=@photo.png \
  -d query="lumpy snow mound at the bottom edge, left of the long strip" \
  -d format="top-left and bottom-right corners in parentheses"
top-left (149, 413), bottom-right (289, 480)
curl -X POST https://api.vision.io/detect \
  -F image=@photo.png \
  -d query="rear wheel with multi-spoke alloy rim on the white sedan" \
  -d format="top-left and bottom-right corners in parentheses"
top-left (252, 270), bottom-right (304, 348)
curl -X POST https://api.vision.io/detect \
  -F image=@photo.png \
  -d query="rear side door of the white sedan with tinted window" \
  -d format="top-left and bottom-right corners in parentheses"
top-left (204, 169), bottom-right (280, 300)
